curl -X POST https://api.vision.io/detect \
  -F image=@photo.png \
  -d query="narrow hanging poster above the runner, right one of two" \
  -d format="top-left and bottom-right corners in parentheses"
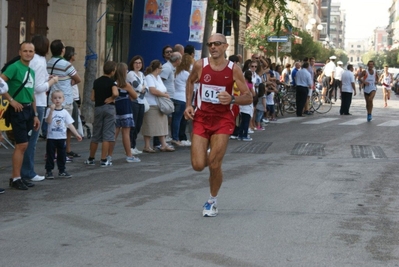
top-left (188, 1), bottom-right (207, 43)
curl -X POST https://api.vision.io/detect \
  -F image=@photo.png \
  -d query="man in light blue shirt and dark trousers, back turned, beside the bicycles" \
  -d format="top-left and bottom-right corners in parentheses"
top-left (295, 62), bottom-right (313, 117)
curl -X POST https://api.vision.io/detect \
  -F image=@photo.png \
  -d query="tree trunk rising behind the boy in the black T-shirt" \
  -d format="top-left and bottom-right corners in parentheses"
top-left (81, 0), bottom-right (101, 122)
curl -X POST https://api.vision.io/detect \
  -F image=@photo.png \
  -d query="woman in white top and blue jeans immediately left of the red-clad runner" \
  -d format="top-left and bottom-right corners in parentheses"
top-left (171, 54), bottom-right (194, 146)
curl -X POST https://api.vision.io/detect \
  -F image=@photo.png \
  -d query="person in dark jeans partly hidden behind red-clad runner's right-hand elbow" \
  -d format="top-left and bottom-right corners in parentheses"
top-left (238, 70), bottom-right (255, 141)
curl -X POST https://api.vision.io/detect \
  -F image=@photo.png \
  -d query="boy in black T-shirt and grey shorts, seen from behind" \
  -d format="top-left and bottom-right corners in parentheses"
top-left (85, 61), bottom-right (119, 167)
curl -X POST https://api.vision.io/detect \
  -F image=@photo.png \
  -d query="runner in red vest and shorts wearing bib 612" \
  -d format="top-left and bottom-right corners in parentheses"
top-left (184, 33), bottom-right (252, 217)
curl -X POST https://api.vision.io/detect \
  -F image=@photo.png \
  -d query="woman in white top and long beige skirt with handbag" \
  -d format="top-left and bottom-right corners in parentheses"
top-left (141, 60), bottom-right (175, 153)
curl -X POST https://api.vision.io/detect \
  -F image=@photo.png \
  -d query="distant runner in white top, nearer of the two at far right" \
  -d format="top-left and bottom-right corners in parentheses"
top-left (360, 60), bottom-right (378, 121)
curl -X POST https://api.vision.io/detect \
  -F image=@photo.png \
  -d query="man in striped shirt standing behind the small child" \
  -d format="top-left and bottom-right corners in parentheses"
top-left (47, 40), bottom-right (81, 158)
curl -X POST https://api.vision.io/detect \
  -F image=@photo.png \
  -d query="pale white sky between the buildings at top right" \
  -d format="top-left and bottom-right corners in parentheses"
top-left (340, 0), bottom-right (392, 43)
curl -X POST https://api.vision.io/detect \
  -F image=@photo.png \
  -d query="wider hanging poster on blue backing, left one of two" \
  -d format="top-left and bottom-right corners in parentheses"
top-left (143, 0), bottom-right (172, 32)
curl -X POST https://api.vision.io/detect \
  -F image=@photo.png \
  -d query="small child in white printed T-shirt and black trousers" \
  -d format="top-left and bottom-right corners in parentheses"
top-left (45, 90), bottom-right (82, 179)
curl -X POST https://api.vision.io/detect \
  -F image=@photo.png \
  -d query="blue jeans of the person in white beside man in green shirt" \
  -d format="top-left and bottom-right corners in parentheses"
top-left (21, 107), bottom-right (46, 179)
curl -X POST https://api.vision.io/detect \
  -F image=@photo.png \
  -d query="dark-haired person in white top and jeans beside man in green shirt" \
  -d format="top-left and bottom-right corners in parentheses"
top-left (21, 35), bottom-right (58, 182)
